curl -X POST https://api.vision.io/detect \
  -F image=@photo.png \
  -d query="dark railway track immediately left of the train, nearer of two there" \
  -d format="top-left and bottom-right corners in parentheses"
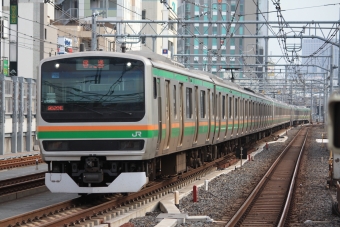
top-left (0, 172), bottom-right (46, 196)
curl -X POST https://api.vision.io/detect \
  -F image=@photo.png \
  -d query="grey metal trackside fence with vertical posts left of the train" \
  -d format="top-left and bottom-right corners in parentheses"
top-left (0, 74), bottom-right (37, 155)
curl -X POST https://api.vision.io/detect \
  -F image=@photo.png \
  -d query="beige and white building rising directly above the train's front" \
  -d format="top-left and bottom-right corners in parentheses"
top-left (52, 0), bottom-right (142, 51)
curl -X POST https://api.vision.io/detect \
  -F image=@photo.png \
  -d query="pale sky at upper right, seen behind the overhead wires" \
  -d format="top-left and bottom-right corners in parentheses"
top-left (269, 0), bottom-right (340, 64)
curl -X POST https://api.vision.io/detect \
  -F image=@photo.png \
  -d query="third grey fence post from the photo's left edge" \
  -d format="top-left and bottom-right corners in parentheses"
top-left (17, 77), bottom-right (24, 152)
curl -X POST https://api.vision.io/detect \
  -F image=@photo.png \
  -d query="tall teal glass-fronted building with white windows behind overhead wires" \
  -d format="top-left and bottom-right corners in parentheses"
top-left (177, 0), bottom-right (268, 78)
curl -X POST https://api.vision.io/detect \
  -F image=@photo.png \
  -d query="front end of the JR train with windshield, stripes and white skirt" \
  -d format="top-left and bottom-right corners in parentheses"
top-left (37, 52), bottom-right (152, 194)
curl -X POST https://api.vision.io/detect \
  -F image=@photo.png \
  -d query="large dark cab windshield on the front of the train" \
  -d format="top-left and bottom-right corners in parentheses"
top-left (41, 57), bottom-right (145, 122)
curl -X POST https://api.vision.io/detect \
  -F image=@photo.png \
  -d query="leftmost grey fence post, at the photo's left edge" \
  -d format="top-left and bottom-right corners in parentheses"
top-left (0, 74), bottom-right (6, 155)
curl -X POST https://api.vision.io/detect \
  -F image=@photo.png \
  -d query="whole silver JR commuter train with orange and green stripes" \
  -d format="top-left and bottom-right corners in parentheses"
top-left (37, 51), bottom-right (310, 194)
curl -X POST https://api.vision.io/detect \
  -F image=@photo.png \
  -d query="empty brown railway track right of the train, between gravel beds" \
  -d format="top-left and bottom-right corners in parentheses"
top-left (223, 127), bottom-right (308, 227)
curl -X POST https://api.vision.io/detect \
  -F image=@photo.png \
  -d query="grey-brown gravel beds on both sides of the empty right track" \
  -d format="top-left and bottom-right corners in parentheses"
top-left (130, 125), bottom-right (340, 227)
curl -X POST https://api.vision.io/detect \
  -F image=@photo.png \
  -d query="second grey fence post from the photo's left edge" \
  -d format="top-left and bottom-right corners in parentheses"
top-left (11, 76), bottom-right (18, 153)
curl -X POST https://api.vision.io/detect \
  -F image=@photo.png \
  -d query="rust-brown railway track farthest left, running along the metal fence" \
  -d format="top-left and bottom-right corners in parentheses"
top-left (0, 155), bottom-right (44, 170)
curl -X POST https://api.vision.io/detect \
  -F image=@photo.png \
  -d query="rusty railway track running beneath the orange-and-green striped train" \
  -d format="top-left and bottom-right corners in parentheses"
top-left (0, 154), bottom-right (235, 227)
